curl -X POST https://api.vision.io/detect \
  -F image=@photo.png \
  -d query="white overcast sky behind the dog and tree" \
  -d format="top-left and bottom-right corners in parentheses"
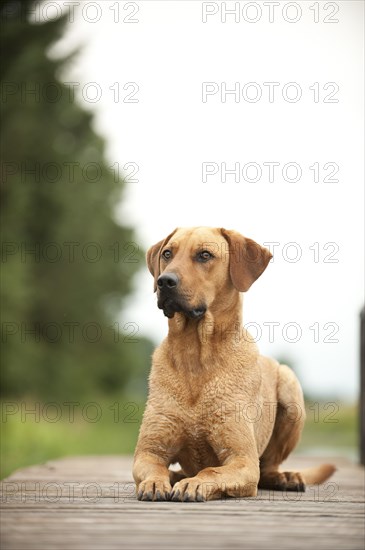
top-left (41, 0), bottom-right (364, 399)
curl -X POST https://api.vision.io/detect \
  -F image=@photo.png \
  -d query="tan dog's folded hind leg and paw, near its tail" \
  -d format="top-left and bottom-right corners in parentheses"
top-left (259, 365), bottom-right (305, 491)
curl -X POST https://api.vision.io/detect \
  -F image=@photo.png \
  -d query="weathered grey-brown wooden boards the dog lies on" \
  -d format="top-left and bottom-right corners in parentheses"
top-left (1, 456), bottom-right (364, 550)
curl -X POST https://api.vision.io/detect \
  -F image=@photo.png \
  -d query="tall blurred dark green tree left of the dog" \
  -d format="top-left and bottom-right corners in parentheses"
top-left (1, 0), bottom-right (152, 400)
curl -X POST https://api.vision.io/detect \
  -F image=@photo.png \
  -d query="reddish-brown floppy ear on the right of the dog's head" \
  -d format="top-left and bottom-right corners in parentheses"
top-left (221, 229), bottom-right (272, 292)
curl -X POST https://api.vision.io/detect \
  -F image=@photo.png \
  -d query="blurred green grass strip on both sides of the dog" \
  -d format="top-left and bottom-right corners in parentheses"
top-left (0, 397), bottom-right (358, 478)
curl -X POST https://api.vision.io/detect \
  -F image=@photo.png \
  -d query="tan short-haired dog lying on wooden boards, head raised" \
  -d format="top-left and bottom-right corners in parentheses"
top-left (133, 227), bottom-right (335, 502)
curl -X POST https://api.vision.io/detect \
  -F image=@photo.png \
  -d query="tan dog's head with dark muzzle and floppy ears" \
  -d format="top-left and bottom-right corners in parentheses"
top-left (147, 227), bottom-right (272, 319)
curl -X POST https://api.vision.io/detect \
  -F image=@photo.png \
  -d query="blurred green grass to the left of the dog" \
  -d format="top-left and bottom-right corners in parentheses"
top-left (0, 398), bottom-right (144, 484)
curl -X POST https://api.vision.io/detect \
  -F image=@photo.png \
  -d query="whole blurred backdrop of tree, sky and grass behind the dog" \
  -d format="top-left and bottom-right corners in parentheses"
top-left (1, 0), bottom-right (364, 476)
